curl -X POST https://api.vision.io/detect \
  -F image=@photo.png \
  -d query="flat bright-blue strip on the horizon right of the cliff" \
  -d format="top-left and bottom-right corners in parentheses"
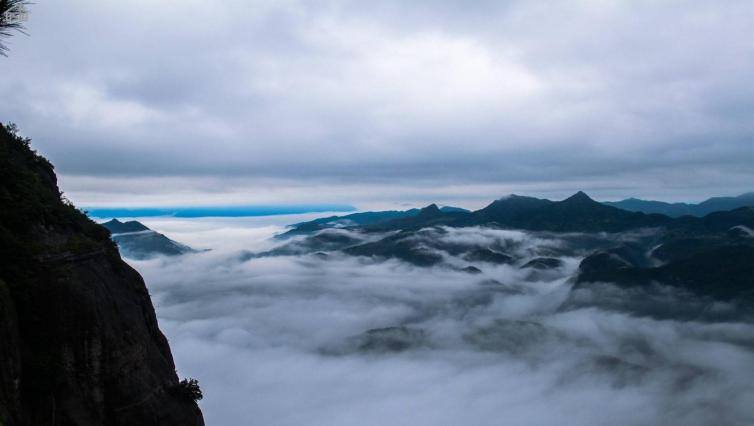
top-left (82, 204), bottom-right (356, 218)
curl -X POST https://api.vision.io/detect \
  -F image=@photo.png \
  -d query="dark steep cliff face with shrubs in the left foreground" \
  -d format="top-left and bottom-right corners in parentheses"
top-left (0, 122), bottom-right (204, 426)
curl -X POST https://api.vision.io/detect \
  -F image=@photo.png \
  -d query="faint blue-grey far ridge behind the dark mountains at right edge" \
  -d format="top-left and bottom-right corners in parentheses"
top-left (603, 192), bottom-right (754, 217)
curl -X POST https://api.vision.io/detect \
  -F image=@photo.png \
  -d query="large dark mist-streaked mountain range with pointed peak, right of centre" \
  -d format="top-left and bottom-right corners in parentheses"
top-left (272, 192), bottom-right (754, 303)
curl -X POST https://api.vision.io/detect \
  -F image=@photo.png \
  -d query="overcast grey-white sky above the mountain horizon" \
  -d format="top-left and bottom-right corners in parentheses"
top-left (0, 0), bottom-right (754, 207)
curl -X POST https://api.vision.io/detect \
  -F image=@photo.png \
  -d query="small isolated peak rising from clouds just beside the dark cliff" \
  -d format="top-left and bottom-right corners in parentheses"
top-left (101, 219), bottom-right (197, 259)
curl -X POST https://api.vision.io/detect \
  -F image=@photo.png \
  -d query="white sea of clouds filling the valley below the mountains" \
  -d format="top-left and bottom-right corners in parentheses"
top-left (128, 217), bottom-right (754, 426)
